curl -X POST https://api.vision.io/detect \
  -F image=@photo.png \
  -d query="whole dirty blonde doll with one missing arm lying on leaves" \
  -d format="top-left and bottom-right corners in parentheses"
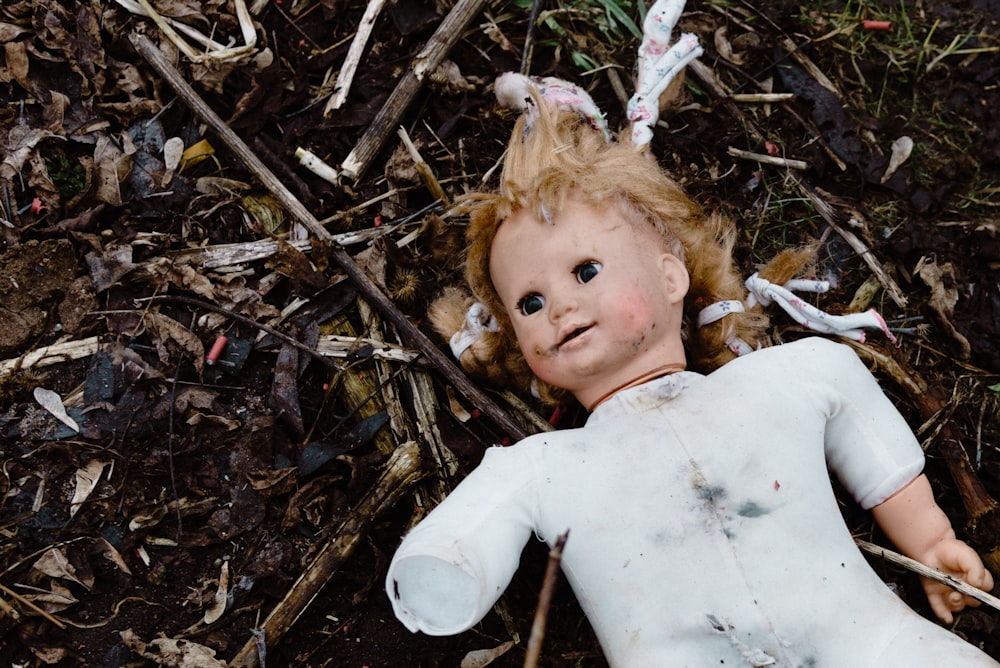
top-left (386, 3), bottom-right (997, 667)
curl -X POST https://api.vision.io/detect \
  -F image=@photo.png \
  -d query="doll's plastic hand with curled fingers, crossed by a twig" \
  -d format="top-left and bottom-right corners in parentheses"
top-left (919, 538), bottom-right (993, 624)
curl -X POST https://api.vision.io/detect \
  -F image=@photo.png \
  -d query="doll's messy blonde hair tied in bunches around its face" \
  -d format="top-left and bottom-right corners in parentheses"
top-left (428, 92), bottom-right (811, 402)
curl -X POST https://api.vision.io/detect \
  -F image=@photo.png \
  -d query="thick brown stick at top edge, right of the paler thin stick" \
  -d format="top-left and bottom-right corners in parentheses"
top-left (340, 0), bottom-right (485, 181)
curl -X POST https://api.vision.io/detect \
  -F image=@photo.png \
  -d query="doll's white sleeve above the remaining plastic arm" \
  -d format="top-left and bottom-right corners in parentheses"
top-left (799, 338), bottom-right (924, 510)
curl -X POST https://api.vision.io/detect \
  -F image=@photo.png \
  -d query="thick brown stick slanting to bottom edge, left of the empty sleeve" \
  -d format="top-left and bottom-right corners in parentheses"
top-left (229, 441), bottom-right (426, 668)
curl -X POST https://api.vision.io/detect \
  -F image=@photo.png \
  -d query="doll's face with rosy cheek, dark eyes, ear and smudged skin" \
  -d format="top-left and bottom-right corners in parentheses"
top-left (490, 198), bottom-right (689, 407)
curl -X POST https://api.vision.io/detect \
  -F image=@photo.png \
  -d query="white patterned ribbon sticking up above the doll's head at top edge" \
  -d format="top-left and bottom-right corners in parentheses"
top-left (627, 0), bottom-right (702, 147)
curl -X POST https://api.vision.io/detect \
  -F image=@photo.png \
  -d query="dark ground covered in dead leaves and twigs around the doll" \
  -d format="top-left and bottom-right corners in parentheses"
top-left (0, 0), bottom-right (1000, 667)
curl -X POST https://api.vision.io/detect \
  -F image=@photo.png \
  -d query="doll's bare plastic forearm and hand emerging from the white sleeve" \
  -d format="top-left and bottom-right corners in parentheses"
top-left (872, 475), bottom-right (993, 624)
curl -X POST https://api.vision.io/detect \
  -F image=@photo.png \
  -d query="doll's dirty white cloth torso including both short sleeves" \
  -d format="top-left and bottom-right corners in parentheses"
top-left (386, 338), bottom-right (997, 668)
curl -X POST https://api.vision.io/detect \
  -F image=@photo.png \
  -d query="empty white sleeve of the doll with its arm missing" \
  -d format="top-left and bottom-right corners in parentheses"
top-left (386, 443), bottom-right (535, 636)
